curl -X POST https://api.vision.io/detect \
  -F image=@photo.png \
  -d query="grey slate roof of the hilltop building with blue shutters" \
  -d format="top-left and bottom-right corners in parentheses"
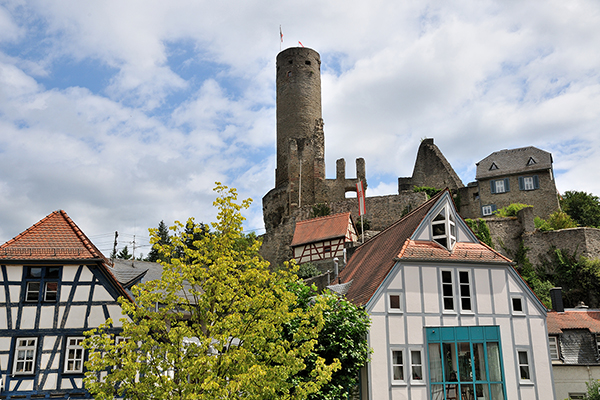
top-left (475, 146), bottom-right (552, 180)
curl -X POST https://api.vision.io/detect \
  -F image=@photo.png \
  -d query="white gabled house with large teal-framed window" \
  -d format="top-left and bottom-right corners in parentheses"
top-left (341, 190), bottom-right (555, 400)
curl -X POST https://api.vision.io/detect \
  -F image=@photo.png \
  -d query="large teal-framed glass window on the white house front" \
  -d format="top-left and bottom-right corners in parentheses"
top-left (425, 326), bottom-right (506, 400)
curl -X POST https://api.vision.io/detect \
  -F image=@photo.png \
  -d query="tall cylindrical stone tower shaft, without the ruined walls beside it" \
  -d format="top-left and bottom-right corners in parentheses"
top-left (275, 47), bottom-right (325, 207)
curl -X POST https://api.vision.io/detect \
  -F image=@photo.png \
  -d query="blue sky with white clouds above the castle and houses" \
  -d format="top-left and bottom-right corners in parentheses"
top-left (0, 0), bottom-right (600, 256)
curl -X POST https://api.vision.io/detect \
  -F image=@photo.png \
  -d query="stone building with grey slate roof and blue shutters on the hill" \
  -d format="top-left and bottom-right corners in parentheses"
top-left (459, 146), bottom-right (560, 219)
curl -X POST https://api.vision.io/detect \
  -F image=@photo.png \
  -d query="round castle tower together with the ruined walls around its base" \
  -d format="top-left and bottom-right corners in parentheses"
top-left (263, 47), bottom-right (367, 233)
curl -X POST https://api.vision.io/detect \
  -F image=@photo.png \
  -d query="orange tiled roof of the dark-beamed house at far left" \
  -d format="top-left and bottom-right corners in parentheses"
top-left (0, 210), bottom-right (105, 261)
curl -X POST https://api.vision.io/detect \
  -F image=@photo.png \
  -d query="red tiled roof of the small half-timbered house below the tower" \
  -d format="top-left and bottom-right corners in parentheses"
top-left (290, 212), bottom-right (352, 247)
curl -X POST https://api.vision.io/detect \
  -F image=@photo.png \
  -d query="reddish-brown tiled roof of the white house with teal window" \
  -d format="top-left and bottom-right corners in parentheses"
top-left (340, 189), bottom-right (510, 305)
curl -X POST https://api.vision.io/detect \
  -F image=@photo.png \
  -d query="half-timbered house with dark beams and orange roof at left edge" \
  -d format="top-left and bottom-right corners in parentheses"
top-left (0, 211), bottom-right (129, 399)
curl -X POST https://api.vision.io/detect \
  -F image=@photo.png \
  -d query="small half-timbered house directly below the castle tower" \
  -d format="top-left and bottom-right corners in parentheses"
top-left (290, 212), bottom-right (358, 264)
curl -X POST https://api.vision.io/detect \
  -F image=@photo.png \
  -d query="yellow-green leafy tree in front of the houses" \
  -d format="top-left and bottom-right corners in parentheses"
top-left (85, 184), bottom-right (340, 400)
